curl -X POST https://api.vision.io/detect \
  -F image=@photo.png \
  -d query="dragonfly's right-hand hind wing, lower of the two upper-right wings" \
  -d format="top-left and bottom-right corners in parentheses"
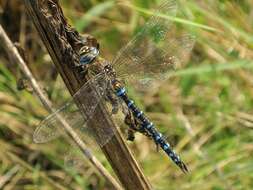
top-left (135, 34), bottom-right (195, 80)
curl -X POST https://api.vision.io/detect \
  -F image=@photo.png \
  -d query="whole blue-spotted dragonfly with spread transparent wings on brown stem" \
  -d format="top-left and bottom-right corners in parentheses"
top-left (34, 0), bottom-right (195, 172)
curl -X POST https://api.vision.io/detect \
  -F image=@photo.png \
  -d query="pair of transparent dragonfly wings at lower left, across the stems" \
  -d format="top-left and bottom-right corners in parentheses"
top-left (33, 73), bottom-right (114, 146)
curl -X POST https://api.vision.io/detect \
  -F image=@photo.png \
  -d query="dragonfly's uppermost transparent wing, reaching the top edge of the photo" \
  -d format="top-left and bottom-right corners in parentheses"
top-left (112, 0), bottom-right (177, 75)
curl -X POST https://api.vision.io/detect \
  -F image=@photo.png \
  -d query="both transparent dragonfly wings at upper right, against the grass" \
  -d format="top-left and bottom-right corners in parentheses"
top-left (112, 0), bottom-right (194, 83)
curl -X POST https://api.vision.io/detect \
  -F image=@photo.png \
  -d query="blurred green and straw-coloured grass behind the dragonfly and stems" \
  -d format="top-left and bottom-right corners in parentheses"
top-left (0, 0), bottom-right (253, 190)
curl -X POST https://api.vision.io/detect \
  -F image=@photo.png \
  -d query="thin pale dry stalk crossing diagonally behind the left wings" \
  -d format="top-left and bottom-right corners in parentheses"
top-left (0, 25), bottom-right (122, 189)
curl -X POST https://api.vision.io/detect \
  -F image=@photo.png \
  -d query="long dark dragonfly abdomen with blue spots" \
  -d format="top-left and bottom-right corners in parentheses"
top-left (116, 87), bottom-right (188, 172)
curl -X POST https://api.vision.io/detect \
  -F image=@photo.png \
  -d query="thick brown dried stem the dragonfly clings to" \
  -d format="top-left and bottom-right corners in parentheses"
top-left (23, 0), bottom-right (151, 190)
